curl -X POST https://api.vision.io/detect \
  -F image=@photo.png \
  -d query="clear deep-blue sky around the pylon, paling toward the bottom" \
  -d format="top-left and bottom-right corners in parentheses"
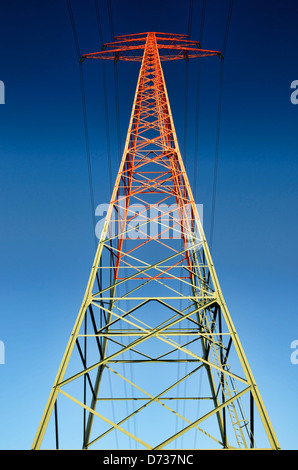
top-left (0, 0), bottom-right (298, 449)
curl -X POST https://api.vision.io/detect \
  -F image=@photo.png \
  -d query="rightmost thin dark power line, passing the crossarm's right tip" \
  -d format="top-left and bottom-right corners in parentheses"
top-left (209, 0), bottom-right (233, 251)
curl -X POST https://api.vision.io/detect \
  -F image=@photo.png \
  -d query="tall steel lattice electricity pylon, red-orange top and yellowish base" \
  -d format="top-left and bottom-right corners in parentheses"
top-left (32, 32), bottom-right (279, 450)
